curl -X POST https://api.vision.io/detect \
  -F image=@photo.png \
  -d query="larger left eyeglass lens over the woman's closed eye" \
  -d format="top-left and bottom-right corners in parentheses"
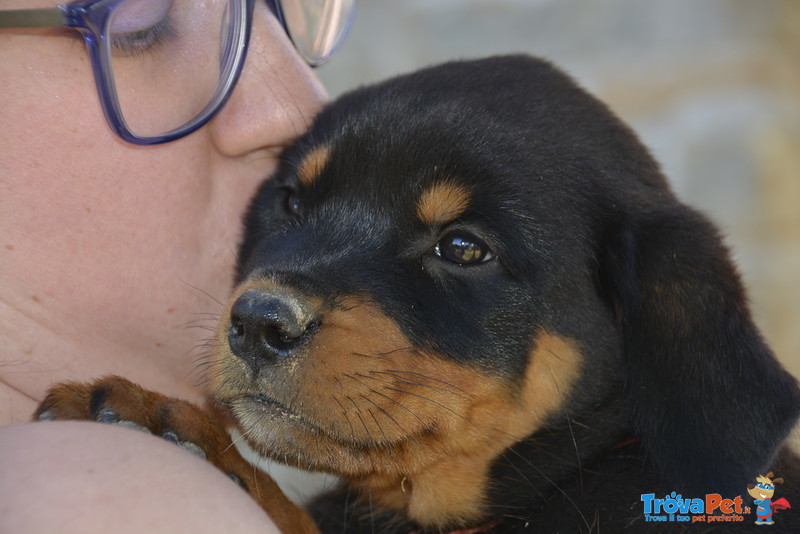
top-left (106, 0), bottom-right (244, 137)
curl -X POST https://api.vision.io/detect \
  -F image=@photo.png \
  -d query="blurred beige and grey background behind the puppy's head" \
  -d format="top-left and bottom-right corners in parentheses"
top-left (318, 0), bottom-right (800, 382)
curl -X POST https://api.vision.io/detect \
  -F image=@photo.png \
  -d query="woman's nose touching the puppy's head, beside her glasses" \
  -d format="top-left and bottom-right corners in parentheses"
top-left (207, 2), bottom-right (327, 157)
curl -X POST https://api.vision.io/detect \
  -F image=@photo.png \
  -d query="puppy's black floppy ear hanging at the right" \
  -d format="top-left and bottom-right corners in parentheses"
top-left (600, 201), bottom-right (800, 496)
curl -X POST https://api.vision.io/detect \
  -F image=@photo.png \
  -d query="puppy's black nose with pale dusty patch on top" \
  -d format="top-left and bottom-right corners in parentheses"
top-left (228, 289), bottom-right (318, 369)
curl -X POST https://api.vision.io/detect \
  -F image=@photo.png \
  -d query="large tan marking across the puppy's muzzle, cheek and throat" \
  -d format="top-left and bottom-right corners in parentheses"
top-left (211, 297), bottom-right (581, 528)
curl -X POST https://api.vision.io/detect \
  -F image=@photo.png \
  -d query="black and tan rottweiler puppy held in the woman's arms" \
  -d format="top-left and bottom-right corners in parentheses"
top-left (38, 56), bottom-right (800, 534)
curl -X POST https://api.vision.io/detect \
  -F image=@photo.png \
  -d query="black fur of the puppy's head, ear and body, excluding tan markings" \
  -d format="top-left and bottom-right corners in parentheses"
top-left (233, 56), bottom-right (800, 533)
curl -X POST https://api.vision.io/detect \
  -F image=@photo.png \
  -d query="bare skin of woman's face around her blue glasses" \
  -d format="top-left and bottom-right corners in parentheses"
top-left (0, 0), bottom-right (325, 394)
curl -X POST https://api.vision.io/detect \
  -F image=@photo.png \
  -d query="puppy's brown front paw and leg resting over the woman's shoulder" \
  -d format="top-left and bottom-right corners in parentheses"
top-left (34, 376), bottom-right (317, 534)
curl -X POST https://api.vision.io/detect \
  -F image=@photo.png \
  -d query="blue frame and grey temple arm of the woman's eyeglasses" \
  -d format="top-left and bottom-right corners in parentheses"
top-left (0, 0), bottom-right (352, 146)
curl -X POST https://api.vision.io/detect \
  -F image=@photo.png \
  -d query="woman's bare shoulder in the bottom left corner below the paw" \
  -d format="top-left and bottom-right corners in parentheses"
top-left (0, 421), bottom-right (277, 533)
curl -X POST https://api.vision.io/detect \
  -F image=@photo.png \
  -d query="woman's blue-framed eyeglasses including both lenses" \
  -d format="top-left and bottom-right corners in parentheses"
top-left (0, 0), bottom-right (355, 145)
